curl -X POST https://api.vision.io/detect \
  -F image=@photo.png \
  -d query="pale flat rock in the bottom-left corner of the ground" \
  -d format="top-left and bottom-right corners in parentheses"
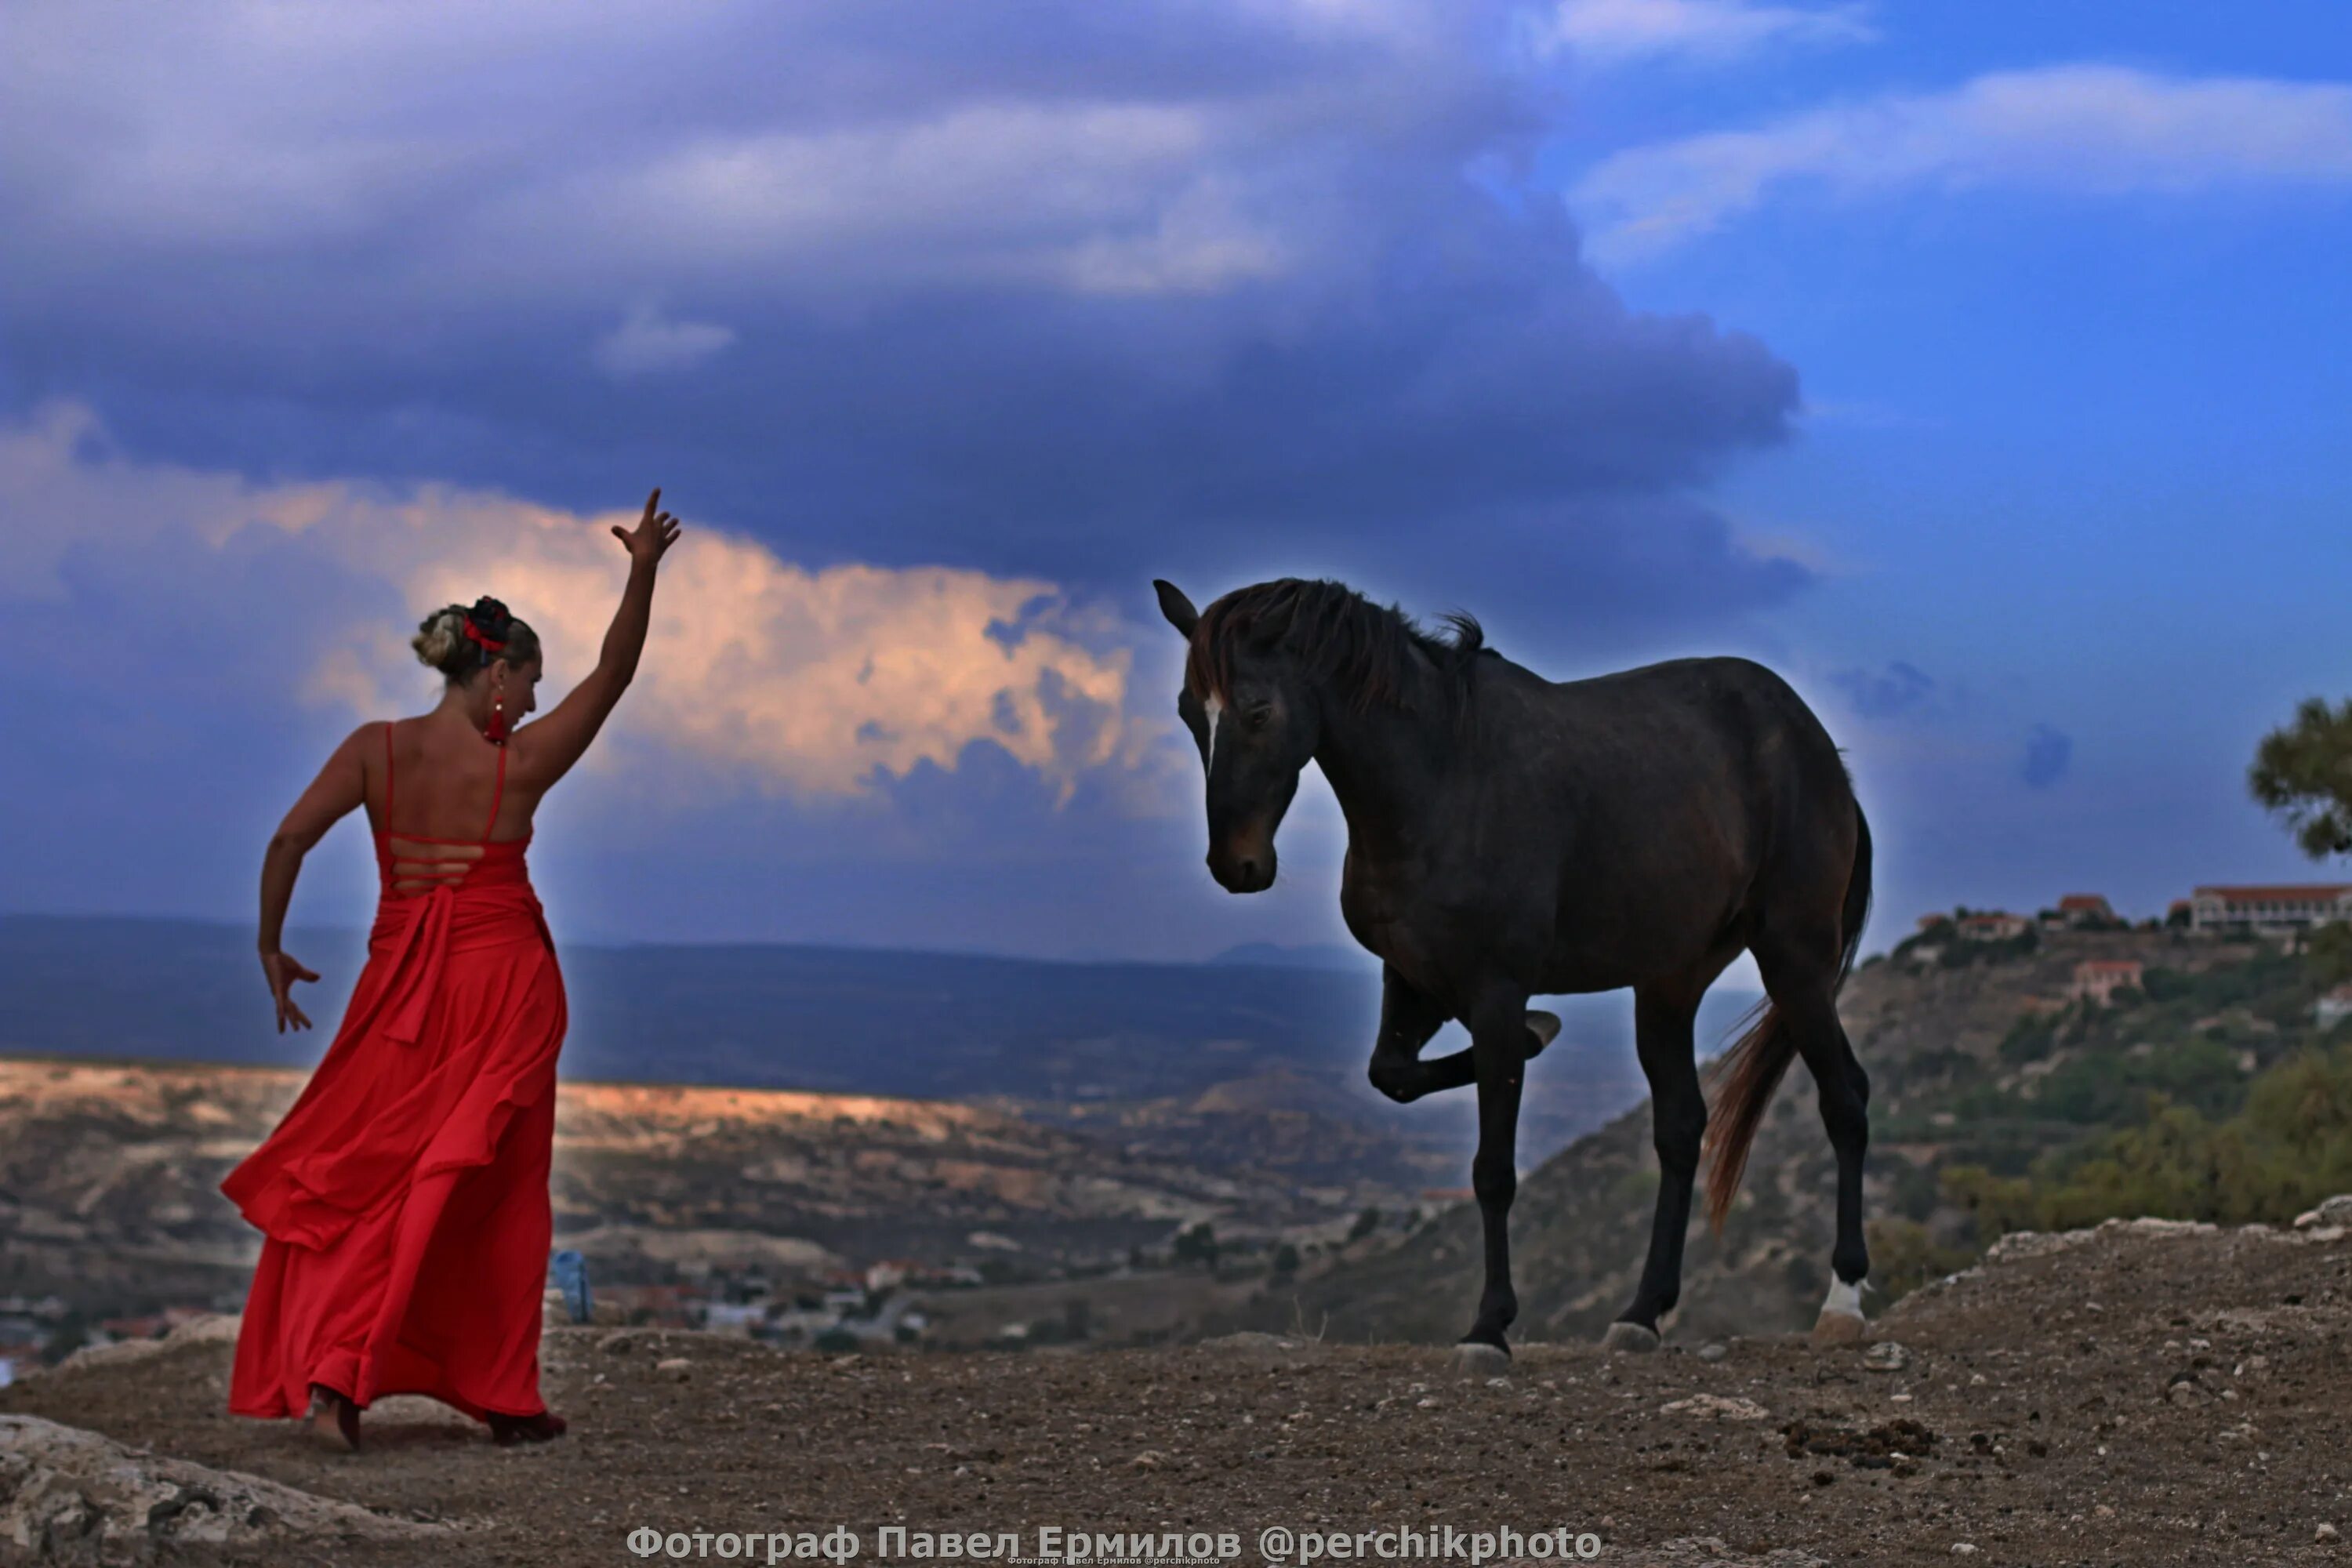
top-left (0, 1415), bottom-right (447, 1563)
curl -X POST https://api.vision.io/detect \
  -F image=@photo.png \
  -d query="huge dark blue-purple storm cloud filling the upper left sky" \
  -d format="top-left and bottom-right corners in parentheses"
top-left (0, 5), bottom-right (1806, 616)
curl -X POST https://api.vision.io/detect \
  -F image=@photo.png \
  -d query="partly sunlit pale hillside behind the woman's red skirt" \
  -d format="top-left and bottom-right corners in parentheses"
top-left (0, 1055), bottom-right (1399, 1316)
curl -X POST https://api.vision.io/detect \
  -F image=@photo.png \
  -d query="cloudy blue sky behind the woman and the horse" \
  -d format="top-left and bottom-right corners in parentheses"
top-left (0, 0), bottom-right (2352, 959)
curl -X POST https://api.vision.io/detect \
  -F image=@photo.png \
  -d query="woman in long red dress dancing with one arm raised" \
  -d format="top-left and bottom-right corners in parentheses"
top-left (221, 489), bottom-right (677, 1448)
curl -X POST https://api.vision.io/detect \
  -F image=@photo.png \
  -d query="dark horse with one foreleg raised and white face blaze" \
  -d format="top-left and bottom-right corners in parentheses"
top-left (1155, 579), bottom-right (1870, 1363)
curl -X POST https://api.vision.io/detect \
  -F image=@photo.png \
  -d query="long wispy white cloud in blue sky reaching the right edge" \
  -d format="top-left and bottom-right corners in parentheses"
top-left (1571, 66), bottom-right (2352, 263)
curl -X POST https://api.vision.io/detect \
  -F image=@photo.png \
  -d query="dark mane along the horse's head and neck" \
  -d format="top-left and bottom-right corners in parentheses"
top-left (1183, 579), bottom-right (1486, 710)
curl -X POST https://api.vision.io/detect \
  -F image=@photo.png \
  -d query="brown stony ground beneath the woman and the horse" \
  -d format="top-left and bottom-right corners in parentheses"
top-left (0, 1210), bottom-right (2352, 1568)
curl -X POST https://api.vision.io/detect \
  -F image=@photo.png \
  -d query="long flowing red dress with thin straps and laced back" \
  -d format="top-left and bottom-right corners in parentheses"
top-left (221, 727), bottom-right (564, 1420)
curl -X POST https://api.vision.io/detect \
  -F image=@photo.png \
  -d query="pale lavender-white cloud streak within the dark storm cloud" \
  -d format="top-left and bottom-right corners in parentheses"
top-left (461, 101), bottom-right (1289, 294)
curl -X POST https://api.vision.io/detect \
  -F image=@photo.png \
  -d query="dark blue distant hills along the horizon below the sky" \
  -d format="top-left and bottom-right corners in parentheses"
top-left (0, 914), bottom-right (1656, 1171)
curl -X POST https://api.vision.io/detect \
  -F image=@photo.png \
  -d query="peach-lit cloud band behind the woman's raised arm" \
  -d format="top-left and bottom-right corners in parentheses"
top-left (0, 405), bottom-right (1155, 797)
